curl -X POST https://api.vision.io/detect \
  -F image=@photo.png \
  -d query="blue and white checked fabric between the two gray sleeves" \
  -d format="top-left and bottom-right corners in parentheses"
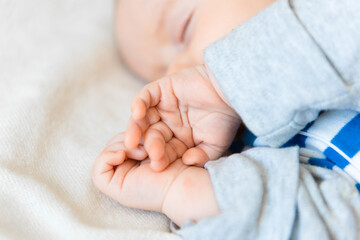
top-left (239, 110), bottom-right (360, 193)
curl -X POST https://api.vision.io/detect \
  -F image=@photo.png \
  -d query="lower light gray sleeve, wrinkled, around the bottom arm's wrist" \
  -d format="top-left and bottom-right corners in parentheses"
top-left (177, 147), bottom-right (360, 240)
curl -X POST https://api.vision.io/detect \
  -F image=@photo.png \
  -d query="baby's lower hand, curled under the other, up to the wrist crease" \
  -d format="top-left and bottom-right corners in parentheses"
top-left (92, 133), bottom-right (188, 212)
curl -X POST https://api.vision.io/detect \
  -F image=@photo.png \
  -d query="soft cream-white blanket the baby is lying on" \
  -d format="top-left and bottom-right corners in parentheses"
top-left (0, 0), bottom-right (179, 240)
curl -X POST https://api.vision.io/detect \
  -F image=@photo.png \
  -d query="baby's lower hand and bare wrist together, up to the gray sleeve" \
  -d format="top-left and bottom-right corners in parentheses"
top-left (92, 133), bottom-right (220, 226)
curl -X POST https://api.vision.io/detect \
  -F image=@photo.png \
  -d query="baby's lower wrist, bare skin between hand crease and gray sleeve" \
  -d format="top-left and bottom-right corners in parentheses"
top-left (162, 167), bottom-right (220, 226)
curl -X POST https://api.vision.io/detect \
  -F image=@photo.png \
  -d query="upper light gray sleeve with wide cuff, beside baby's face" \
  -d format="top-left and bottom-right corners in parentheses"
top-left (204, 0), bottom-right (360, 146)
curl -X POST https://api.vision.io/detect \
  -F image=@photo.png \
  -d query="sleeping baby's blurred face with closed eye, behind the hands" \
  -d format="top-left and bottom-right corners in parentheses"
top-left (116, 0), bottom-right (275, 81)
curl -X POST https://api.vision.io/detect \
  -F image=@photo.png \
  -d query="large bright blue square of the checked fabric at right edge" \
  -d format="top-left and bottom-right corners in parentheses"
top-left (331, 114), bottom-right (360, 158)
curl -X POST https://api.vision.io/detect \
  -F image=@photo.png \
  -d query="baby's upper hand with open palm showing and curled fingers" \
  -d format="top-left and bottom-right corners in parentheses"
top-left (125, 66), bottom-right (240, 171)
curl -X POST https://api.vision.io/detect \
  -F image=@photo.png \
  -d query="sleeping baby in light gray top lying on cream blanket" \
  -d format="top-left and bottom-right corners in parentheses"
top-left (92, 0), bottom-right (360, 239)
